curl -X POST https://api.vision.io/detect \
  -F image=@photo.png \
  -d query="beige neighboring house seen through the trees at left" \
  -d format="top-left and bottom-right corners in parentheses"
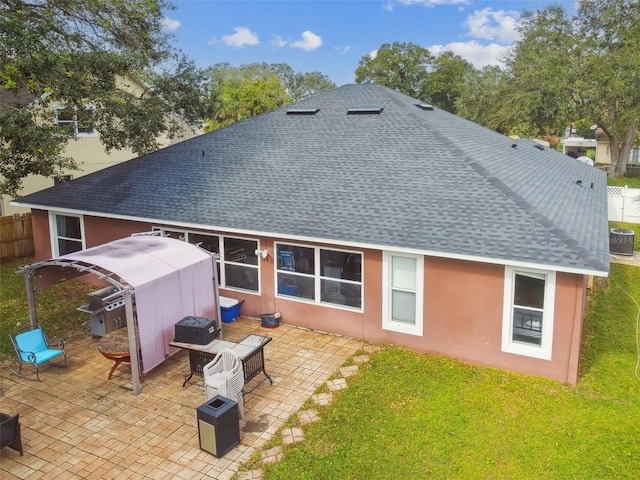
top-left (0, 78), bottom-right (195, 216)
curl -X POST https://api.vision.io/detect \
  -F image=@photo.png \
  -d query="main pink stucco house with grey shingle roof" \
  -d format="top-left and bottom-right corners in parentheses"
top-left (12, 85), bottom-right (609, 385)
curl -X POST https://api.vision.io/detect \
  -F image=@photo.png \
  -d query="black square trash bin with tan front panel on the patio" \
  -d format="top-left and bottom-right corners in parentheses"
top-left (196, 395), bottom-right (240, 458)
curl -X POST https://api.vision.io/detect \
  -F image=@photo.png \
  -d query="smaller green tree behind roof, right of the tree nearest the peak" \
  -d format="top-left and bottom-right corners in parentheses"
top-left (427, 51), bottom-right (474, 113)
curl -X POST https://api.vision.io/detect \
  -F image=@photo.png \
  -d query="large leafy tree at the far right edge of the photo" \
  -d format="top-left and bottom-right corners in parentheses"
top-left (507, 0), bottom-right (640, 177)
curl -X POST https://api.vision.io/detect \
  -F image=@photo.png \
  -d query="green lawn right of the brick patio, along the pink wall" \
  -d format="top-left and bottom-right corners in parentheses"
top-left (251, 255), bottom-right (640, 480)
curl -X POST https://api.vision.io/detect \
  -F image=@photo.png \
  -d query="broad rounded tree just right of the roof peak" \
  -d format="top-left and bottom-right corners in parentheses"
top-left (356, 42), bottom-right (434, 100)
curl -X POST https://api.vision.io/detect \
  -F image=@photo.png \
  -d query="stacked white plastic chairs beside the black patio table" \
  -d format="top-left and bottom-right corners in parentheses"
top-left (202, 349), bottom-right (244, 418)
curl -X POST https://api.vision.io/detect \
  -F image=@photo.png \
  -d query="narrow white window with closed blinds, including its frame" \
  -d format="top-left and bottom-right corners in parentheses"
top-left (382, 252), bottom-right (424, 336)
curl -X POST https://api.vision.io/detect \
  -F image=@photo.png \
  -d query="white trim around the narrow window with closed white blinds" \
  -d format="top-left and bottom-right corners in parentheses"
top-left (382, 251), bottom-right (424, 337)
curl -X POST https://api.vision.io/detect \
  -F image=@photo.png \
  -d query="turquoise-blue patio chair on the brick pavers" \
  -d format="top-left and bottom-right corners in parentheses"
top-left (9, 325), bottom-right (67, 380)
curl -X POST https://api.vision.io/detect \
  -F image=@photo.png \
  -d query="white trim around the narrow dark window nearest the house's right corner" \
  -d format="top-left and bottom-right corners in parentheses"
top-left (502, 266), bottom-right (556, 360)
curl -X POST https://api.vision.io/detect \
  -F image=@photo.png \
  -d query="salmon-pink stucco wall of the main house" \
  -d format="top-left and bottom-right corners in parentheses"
top-left (32, 211), bottom-right (587, 385)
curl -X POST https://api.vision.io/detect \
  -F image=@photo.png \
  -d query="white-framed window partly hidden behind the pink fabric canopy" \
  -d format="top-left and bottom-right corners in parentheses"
top-left (154, 227), bottom-right (260, 292)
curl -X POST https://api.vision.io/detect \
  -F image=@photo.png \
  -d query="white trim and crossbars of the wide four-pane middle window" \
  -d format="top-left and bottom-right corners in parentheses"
top-left (273, 242), bottom-right (364, 313)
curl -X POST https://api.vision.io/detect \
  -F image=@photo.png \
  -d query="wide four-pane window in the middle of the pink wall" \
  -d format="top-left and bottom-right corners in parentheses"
top-left (276, 244), bottom-right (362, 309)
